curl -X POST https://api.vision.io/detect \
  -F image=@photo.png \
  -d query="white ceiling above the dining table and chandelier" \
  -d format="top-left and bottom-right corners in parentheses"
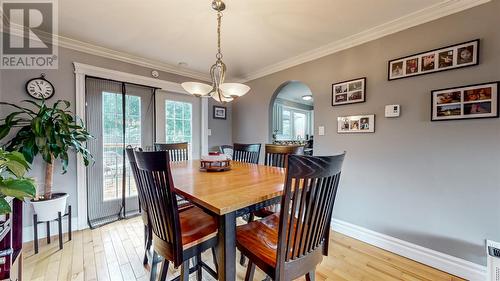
top-left (59, 0), bottom-right (484, 80)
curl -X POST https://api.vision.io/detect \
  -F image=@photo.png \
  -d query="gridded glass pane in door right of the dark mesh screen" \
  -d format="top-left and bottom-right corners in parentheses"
top-left (165, 100), bottom-right (193, 144)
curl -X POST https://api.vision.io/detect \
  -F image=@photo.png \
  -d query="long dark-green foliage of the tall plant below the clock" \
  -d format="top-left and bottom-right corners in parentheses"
top-left (0, 100), bottom-right (93, 173)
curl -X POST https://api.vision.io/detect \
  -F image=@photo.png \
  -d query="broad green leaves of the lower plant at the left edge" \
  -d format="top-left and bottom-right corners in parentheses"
top-left (0, 148), bottom-right (36, 213)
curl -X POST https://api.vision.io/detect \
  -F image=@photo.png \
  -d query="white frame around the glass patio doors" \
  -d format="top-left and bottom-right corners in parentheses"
top-left (73, 62), bottom-right (208, 230)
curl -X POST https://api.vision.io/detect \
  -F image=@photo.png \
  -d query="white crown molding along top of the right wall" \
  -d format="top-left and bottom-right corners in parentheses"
top-left (238, 0), bottom-right (491, 83)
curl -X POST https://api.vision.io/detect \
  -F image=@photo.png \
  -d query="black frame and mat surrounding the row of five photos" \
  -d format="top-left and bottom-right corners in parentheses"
top-left (387, 39), bottom-right (481, 81)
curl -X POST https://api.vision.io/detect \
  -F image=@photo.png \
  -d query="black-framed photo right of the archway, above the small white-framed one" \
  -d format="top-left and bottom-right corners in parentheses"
top-left (332, 77), bottom-right (366, 106)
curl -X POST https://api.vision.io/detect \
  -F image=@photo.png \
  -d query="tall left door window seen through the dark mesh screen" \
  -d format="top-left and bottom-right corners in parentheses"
top-left (102, 92), bottom-right (141, 201)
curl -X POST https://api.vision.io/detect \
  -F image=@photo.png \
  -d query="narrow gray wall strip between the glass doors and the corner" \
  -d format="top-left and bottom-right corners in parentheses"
top-left (208, 98), bottom-right (233, 151)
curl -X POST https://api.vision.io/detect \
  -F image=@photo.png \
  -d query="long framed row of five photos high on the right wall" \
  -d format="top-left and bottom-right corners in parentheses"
top-left (388, 39), bottom-right (479, 81)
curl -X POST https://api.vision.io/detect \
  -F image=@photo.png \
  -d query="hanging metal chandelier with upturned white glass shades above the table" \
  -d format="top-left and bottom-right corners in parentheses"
top-left (181, 0), bottom-right (250, 103)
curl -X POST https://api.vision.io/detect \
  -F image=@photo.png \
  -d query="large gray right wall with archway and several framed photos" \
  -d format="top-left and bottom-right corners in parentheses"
top-left (233, 0), bottom-right (500, 265)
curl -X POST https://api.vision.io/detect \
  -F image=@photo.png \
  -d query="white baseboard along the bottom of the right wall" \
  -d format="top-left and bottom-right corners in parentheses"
top-left (332, 219), bottom-right (486, 281)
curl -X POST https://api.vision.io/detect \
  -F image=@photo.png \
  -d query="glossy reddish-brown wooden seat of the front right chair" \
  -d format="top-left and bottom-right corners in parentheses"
top-left (236, 214), bottom-right (279, 272)
